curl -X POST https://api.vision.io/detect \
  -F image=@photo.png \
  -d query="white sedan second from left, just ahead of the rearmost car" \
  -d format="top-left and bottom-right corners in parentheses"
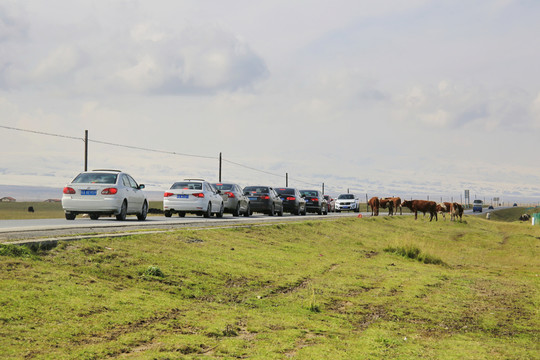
top-left (163, 179), bottom-right (225, 218)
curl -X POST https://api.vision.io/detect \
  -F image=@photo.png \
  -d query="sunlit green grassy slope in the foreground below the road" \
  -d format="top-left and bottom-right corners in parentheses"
top-left (0, 217), bottom-right (540, 359)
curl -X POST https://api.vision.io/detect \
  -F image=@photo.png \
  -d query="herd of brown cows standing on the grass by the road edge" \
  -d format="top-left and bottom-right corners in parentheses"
top-left (368, 196), bottom-right (463, 221)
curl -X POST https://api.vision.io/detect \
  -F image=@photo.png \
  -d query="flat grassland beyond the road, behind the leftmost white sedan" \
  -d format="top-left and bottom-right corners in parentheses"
top-left (0, 201), bottom-right (163, 220)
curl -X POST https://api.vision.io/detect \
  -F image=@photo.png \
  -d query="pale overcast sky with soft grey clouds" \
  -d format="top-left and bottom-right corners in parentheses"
top-left (0, 0), bottom-right (540, 201)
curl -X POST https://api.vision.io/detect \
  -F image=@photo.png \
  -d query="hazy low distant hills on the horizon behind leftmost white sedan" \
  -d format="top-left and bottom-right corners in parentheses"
top-left (0, 185), bottom-right (163, 201)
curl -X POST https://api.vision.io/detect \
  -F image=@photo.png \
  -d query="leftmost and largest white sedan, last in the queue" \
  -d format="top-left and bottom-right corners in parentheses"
top-left (62, 169), bottom-right (148, 221)
